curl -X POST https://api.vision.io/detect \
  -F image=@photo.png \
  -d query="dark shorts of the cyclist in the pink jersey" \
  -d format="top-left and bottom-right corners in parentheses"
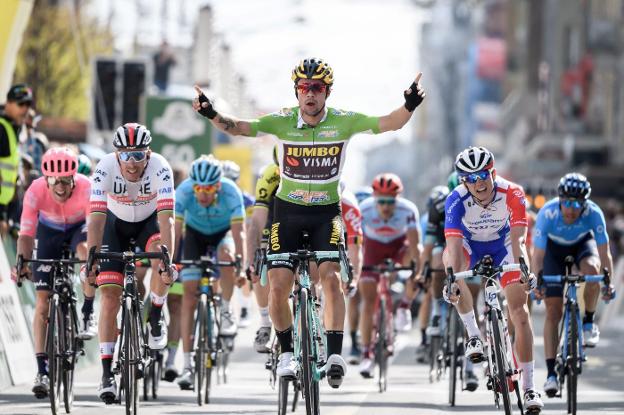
top-left (33, 222), bottom-right (87, 291)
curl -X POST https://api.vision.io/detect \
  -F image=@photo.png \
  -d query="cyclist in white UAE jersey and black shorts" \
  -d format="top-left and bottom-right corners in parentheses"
top-left (87, 123), bottom-right (177, 404)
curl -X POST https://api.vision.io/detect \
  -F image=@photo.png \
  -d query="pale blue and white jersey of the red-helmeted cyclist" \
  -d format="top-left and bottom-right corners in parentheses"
top-left (360, 197), bottom-right (420, 244)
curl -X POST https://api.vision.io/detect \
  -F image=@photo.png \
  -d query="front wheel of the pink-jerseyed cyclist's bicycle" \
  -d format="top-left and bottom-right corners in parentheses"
top-left (46, 294), bottom-right (63, 415)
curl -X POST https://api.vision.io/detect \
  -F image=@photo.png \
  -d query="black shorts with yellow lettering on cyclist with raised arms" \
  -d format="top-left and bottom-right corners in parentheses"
top-left (267, 198), bottom-right (344, 271)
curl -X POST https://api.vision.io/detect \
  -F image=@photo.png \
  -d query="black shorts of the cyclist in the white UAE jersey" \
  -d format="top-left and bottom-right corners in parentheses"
top-left (97, 210), bottom-right (160, 286)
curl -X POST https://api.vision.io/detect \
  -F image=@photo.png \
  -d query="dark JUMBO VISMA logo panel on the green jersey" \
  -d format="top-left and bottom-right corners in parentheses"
top-left (283, 143), bottom-right (344, 180)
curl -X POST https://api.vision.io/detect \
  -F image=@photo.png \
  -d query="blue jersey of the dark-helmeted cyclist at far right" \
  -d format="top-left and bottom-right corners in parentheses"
top-left (533, 197), bottom-right (609, 249)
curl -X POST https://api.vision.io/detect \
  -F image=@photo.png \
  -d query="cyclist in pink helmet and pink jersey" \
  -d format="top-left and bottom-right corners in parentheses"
top-left (12, 147), bottom-right (97, 399)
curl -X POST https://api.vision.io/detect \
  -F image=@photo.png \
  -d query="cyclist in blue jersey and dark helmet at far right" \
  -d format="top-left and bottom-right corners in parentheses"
top-left (532, 173), bottom-right (613, 396)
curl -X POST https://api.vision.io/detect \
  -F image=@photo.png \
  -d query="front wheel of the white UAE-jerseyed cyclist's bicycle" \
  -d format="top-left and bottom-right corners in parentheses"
top-left (122, 297), bottom-right (139, 415)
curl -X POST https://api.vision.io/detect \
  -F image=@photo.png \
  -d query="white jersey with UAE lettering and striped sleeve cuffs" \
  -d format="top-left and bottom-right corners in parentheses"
top-left (91, 153), bottom-right (175, 222)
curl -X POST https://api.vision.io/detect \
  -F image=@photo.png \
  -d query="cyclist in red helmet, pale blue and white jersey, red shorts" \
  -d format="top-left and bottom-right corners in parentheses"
top-left (358, 173), bottom-right (421, 378)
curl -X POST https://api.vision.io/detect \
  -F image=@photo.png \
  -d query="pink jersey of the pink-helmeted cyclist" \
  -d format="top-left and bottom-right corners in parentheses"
top-left (20, 174), bottom-right (91, 238)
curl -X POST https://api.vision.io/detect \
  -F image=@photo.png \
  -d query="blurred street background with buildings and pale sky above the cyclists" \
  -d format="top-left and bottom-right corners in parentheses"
top-left (0, 0), bottom-right (624, 392)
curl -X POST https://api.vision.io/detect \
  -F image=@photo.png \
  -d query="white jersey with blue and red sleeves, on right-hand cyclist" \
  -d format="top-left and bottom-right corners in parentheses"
top-left (444, 177), bottom-right (528, 242)
